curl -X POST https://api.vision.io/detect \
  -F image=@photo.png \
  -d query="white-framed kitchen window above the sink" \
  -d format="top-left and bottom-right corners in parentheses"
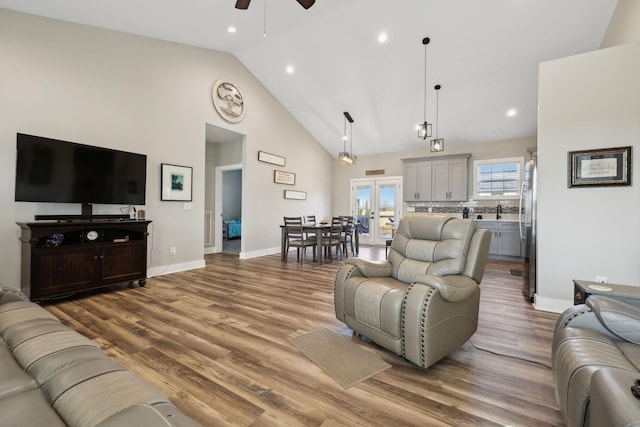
top-left (473, 157), bottom-right (524, 199)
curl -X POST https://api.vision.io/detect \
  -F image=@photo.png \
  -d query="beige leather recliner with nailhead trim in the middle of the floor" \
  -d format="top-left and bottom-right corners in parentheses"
top-left (335, 216), bottom-right (491, 368)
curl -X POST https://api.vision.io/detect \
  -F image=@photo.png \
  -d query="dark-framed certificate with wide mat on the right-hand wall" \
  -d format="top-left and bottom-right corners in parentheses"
top-left (567, 146), bottom-right (631, 188)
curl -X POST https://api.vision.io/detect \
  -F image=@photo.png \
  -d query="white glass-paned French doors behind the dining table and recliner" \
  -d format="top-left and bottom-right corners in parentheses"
top-left (351, 177), bottom-right (402, 245)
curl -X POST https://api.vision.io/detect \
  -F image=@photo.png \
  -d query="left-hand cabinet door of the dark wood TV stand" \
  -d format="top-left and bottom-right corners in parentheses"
top-left (31, 247), bottom-right (97, 299)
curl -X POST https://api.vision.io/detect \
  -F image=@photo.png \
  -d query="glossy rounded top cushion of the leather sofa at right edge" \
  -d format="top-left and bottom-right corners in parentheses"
top-left (586, 295), bottom-right (640, 344)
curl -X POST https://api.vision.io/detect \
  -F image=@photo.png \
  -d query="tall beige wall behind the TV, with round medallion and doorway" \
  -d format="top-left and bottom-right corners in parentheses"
top-left (0, 9), bottom-right (333, 286)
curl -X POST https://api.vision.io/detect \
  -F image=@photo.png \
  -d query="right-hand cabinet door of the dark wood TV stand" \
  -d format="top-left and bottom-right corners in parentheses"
top-left (101, 241), bottom-right (147, 284)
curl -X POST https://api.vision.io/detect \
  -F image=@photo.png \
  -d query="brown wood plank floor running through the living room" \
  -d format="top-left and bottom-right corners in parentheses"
top-left (45, 247), bottom-right (563, 427)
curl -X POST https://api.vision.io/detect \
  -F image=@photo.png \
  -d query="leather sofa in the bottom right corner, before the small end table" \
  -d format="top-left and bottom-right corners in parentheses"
top-left (552, 295), bottom-right (640, 427)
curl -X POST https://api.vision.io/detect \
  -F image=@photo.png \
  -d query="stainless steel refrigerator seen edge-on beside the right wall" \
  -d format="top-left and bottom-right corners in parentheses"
top-left (518, 149), bottom-right (538, 302)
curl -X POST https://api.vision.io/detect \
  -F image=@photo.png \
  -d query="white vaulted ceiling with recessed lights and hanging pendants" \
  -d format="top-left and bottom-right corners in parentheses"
top-left (0, 0), bottom-right (617, 155)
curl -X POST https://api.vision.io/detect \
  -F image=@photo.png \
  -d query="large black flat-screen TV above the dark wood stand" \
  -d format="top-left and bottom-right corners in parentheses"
top-left (15, 133), bottom-right (147, 205)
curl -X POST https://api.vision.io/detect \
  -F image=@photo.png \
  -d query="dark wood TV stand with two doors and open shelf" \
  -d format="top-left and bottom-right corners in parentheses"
top-left (18, 220), bottom-right (151, 300)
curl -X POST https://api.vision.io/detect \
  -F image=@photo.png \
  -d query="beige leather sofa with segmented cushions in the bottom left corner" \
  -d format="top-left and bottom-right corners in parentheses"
top-left (0, 286), bottom-right (199, 427)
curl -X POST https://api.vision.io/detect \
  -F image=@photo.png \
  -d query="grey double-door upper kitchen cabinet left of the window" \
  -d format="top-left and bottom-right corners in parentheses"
top-left (402, 154), bottom-right (471, 202)
